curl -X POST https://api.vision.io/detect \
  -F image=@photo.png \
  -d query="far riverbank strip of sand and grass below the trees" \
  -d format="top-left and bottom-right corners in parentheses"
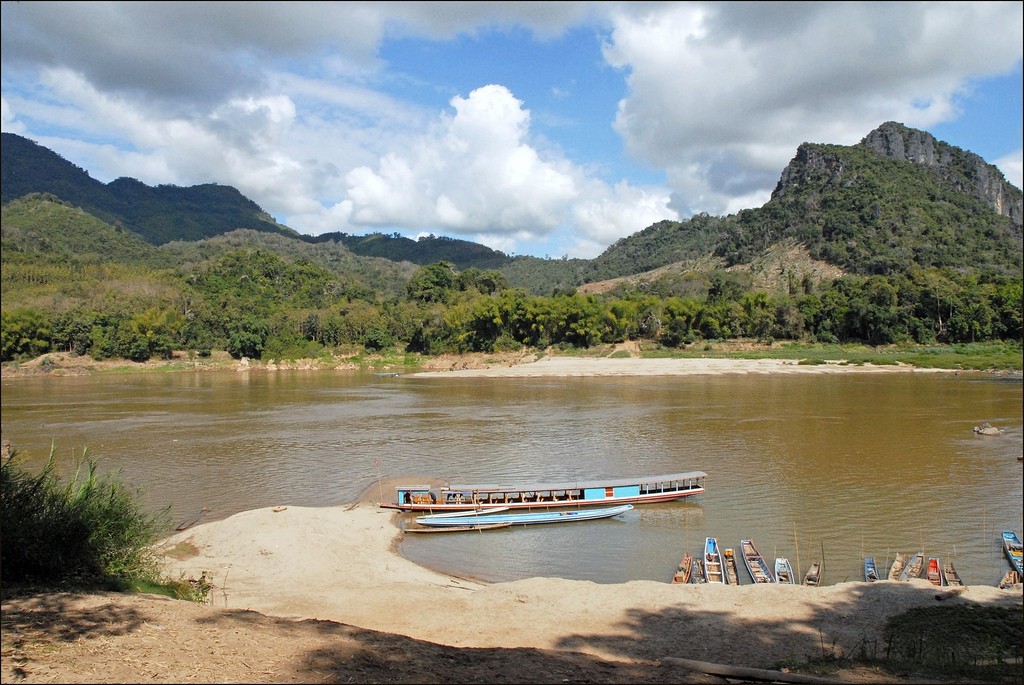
top-left (0, 341), bottom-right (1024, 379)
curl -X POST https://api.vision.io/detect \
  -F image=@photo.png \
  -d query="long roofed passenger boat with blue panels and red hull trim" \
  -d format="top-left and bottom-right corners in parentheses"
top-left (380, 471), bottom-right (708, 512)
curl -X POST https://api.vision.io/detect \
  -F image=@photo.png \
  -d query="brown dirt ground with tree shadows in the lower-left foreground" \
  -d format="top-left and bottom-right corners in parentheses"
top-left (0, 594), bottom-right (737, 683)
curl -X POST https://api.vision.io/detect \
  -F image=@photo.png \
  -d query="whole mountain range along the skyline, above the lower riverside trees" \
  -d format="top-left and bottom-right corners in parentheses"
top-left (0, 122), bottom-right (1024, 293)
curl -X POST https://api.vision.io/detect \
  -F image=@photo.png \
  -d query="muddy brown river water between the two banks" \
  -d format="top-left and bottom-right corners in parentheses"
top-left (2, 371), bottom-right (1024, 585)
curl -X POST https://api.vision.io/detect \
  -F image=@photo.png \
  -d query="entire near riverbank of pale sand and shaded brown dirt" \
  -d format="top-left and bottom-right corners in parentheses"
top-left (12, 494), bottom-right (1022, 683)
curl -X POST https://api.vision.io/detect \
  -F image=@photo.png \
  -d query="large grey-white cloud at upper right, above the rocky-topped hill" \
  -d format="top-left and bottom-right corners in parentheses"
top-left (605, 3), bottom-right (1022, 215)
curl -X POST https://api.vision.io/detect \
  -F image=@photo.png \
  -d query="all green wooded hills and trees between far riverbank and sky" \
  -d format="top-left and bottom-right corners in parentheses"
top-left (0, 124), bottom-right (1024, 368)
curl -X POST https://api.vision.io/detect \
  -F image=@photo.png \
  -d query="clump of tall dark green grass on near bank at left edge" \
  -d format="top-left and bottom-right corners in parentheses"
top-left (0, 447), bottom-right (170, 590)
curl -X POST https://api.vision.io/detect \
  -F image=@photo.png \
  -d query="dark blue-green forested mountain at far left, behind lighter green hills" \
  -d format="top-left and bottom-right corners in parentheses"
top-left (0, 133), bottom-right (298, 245)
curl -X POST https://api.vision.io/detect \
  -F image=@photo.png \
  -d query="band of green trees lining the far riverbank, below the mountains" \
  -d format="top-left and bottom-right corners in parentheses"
top-left (0, 249), bottom-right (1022, 361)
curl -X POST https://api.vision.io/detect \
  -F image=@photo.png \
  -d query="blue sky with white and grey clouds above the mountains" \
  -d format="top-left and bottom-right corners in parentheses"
top-left (0, 1), bottom-right (1024, 259)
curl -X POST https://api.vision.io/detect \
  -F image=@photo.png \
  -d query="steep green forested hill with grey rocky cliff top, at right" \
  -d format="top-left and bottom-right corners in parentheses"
top-left (585, 122), bottom-right (1024, 282)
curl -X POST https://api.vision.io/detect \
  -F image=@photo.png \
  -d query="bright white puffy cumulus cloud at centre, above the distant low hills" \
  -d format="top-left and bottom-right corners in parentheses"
top-left (346, 85), bottom-right (577, 234)
